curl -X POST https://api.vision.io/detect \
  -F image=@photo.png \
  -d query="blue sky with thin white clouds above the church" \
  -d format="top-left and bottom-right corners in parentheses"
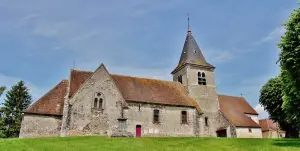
top-left (0, 0), bottom-right (299, 118)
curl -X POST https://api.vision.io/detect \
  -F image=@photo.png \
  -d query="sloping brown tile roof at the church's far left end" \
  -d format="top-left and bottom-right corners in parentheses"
top-left (23, 80), bottom-right (68, 115)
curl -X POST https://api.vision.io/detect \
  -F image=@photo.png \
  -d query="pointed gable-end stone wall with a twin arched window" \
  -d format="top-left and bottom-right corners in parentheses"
top-left (67, 66), bottom-right (123, 136)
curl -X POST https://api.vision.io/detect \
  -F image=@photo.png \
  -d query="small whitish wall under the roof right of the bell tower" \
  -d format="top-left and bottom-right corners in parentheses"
top-left (236, 127), bottom-right (262, 138)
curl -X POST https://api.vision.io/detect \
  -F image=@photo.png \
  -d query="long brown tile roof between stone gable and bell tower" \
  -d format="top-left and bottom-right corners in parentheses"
top-left (111, 75), bottom-right (200, 111)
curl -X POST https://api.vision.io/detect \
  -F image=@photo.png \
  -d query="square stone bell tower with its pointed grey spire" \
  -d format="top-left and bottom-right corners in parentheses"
top-left (172, 18), bottom-right (219, 136)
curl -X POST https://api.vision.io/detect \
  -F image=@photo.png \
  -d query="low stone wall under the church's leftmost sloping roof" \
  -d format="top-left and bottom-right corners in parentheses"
top-left (19, 114), bottom-right (61, 138)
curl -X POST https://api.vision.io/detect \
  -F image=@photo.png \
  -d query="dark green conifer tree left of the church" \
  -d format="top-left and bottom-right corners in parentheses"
top-left (0, 81), bottom-right (31, 138)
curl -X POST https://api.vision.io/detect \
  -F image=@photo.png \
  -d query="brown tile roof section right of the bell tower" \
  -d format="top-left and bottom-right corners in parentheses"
top-left (218, 95), bottom-right (260, 127)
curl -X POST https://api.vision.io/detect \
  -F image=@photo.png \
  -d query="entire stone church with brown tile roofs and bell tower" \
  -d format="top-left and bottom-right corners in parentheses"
top-left (20, 26), bottom-right (262, 138)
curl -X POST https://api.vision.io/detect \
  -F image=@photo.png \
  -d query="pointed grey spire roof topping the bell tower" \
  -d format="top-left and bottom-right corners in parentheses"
top-left (172, 30), bottom-right (215, 73)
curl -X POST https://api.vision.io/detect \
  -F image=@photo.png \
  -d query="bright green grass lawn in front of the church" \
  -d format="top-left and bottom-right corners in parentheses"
top-left (0, 137), bottom-right (300, 151)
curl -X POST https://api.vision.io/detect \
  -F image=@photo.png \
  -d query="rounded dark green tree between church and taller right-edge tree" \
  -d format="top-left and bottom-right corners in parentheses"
top-left (259, 77), bottom-right (299, 138)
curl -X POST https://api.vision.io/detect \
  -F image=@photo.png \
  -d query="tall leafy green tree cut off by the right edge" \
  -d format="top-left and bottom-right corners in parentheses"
top-left (278, 5), bottom-right (300, 129)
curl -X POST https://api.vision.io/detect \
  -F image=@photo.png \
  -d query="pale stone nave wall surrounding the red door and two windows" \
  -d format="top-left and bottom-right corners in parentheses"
top-left (124, 103), bottom-right (198, 137)
